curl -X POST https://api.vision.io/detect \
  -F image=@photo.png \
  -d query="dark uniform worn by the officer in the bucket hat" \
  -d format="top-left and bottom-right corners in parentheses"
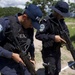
top-left (36, 14), bottom-right (68, 75)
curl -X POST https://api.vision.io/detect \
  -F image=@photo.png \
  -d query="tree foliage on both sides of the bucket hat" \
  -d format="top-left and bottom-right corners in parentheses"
top-left (26, 0), bottom-right (75, 15)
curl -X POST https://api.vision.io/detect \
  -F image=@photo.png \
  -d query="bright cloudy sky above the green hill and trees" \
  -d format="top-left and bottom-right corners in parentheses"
top-left (0, 0), bottom-right (75, 9)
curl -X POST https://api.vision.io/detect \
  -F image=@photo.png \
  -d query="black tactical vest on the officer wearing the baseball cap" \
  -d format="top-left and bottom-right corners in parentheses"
top-left (4, 16), bottom-right (31, 52)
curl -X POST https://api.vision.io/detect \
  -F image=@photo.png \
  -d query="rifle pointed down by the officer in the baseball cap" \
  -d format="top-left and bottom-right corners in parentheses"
top-left (13, 35), bottom-right (37, 75)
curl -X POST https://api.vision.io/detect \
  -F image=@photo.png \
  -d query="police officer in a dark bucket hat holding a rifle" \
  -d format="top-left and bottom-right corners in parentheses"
top-left (36, 1), bottom-right (70, 75)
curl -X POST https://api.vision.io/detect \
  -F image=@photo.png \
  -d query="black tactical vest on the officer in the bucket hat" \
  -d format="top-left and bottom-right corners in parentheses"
top-left (43, 16), bottom-right (60, 48)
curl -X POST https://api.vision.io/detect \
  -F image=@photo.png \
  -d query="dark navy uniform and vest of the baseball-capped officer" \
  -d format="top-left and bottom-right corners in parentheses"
top-left (0, 13), bottom-right (34, 75)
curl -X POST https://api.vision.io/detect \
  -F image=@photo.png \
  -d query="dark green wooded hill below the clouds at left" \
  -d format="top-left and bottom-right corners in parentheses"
top-left (0, 7), bottom-right (22, 17)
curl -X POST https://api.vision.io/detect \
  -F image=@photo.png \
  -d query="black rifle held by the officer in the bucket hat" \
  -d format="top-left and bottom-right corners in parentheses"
top-left (59, 21), bottom-right (75, 61)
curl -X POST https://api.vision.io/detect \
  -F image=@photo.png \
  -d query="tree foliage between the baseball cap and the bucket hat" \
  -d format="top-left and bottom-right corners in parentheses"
top-left (26, 0), bottom-right (56, 15)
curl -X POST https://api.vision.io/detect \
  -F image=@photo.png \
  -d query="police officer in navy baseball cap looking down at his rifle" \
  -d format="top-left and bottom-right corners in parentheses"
top-left (0, 4), bottom-right (42, 75)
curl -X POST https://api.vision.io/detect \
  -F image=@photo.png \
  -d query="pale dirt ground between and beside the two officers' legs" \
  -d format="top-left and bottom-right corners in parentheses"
top-left (34, 32), bottom-right (75, 75)
